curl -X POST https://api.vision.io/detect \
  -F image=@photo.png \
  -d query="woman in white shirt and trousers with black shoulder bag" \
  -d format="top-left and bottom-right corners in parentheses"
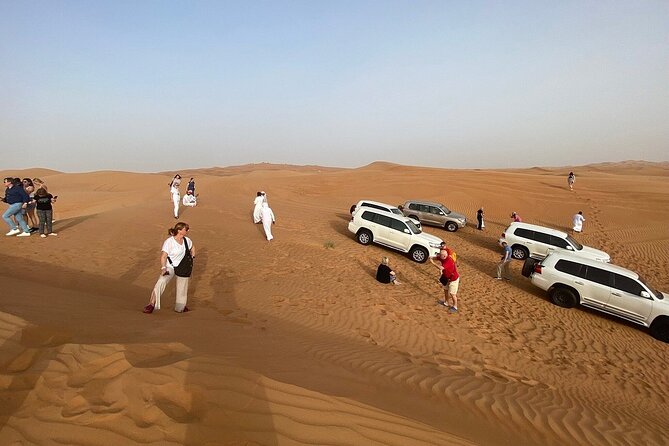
top-left (144, 222), bottom-right (195, 313)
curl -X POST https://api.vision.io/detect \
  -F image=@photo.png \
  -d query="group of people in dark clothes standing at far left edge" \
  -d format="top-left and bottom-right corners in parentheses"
top-left (2, 177), bottom-right (58, 238)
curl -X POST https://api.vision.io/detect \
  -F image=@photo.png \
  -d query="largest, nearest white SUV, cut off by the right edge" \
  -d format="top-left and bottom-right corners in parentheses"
top-left (523, 252), bottom-right (669, 342)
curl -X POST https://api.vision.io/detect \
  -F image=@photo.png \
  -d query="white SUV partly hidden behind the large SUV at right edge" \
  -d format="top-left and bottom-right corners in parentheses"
top-left (504, 222), bottom-right (611, 262)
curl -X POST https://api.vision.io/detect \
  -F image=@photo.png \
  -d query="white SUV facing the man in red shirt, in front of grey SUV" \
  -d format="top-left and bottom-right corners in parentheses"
top-left (348, 207), bottom-right (442, 263)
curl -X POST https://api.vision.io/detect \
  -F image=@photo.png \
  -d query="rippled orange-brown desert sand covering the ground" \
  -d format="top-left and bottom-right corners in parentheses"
top-left (0, 162), bottom-right (669, 446)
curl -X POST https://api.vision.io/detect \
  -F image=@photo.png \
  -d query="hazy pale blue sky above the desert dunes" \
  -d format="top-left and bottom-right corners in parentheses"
top-left (0, 0), bottom-right (669, 172)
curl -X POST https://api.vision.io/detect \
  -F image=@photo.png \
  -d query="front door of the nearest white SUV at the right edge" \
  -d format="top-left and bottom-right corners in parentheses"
top-left (605, 273), bottom-right (653, 325)
